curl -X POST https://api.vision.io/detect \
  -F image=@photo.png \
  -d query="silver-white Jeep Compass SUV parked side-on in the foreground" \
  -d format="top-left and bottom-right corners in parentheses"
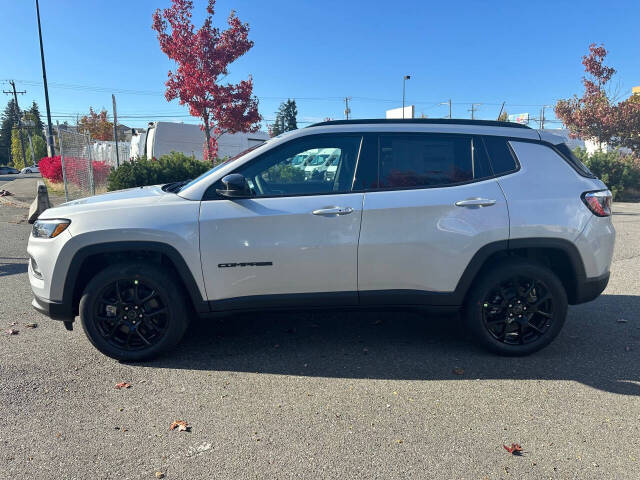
top-left (28, 120), bottom-right (615, 361)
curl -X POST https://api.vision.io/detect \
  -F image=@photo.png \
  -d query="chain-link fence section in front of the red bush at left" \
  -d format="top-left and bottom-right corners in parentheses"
top-left (58, 130), bottom-right (111, 201)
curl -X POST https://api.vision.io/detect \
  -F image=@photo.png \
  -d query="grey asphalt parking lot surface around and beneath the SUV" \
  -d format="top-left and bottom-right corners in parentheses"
top-left (0, 203), bottom-right (640, 479)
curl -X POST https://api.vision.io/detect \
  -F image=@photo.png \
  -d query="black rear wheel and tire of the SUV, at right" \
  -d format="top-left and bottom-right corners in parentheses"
top-left (465, 258), bottom-right (567, 356)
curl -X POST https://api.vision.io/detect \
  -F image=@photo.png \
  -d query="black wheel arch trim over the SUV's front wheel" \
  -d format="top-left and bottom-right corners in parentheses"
top-left (61, 241), bottom-right (209, 318)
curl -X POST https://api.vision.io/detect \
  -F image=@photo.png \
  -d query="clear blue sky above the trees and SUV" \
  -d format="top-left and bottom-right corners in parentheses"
top-left (0, 0), bottom-right (640, 128)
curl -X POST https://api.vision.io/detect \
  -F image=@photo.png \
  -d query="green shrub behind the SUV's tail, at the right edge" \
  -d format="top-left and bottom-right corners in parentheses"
top-left (574, 148), bottom-right (640, 201)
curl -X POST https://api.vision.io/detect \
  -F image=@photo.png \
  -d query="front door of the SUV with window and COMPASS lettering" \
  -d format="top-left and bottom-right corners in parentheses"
top-left (200, 135), bottom-right (363, 310)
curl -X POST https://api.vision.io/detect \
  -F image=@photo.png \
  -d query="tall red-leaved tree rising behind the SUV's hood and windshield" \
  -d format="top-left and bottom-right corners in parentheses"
top-left (152, 0), bottom-right (261, 161)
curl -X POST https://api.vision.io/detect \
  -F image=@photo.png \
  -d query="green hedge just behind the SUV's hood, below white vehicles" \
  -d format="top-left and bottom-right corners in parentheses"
top-left (107, 152), bottom-right (211, 191)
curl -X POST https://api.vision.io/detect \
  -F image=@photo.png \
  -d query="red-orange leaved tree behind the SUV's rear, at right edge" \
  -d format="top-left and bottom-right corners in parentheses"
top-left (555, 44), bottom-right (640, 152)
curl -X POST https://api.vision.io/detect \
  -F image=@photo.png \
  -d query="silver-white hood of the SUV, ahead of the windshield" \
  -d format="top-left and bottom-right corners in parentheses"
top-left (40, 185), bottom-right (174, 218)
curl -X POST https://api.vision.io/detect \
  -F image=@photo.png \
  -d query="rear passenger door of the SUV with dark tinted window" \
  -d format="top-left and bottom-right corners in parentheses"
top-left (358, 133), bottom-right (509, 305)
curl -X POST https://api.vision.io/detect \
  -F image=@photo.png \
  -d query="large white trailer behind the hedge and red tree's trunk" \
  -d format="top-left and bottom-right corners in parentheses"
top-left (138, 122), bottom-right (269, 160)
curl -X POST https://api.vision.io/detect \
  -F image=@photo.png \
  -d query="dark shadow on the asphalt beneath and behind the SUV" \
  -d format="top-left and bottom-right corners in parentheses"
top-left (144, 295), bottom-right (640, 395)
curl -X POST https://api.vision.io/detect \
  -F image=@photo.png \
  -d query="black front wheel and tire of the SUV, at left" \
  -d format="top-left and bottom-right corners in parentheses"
top-left (79, 263), bottom-right (189, 361)
